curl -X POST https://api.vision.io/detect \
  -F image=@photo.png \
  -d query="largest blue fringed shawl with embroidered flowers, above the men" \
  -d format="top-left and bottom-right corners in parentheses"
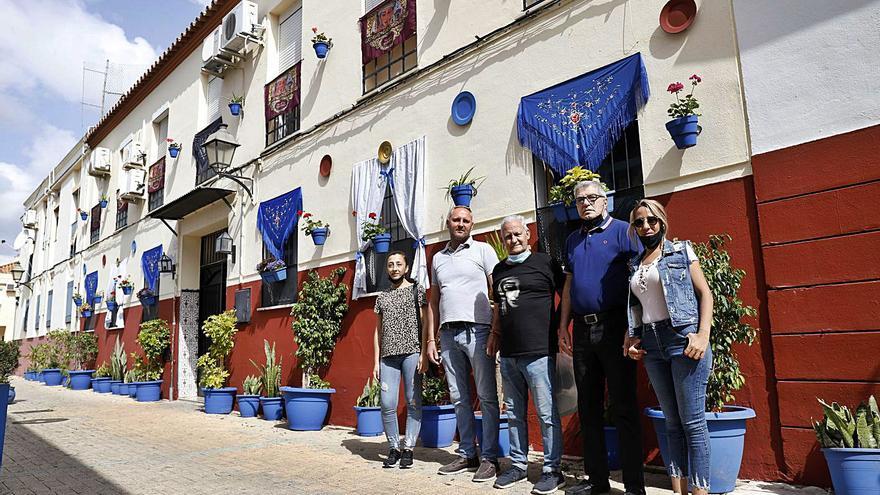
top-left (516, 53), bottom-right (650, 176)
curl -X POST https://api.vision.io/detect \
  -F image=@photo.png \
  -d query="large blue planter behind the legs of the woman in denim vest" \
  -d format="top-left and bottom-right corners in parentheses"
top-left (645, 406), bottom-right (755, 493)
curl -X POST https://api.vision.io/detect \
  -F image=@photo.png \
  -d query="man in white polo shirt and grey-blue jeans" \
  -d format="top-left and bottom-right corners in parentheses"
top-left (422, 206), bottom-right (499, 482)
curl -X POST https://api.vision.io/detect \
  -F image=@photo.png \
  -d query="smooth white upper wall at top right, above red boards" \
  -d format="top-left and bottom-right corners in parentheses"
top-left (734, 0), bottom-right (880, 155)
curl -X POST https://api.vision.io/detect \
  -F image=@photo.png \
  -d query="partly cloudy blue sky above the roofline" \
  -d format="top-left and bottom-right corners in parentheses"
top-left (0, 0), bottom-right (209, 262)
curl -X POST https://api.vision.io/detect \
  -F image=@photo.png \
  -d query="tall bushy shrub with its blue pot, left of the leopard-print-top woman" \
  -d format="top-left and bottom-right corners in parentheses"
top-left (281, 267), bottom-right (348, 430)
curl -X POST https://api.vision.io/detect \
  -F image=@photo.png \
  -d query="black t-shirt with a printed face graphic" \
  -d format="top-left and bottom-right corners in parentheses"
top-left (492, 253), bottom-right (565, 357)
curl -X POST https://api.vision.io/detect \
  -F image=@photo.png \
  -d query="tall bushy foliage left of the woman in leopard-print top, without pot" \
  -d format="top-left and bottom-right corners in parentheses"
top-left (291, 267), bottom-right (348, 388)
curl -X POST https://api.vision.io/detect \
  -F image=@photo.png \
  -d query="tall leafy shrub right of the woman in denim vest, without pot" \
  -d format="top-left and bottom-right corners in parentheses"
top-left (694, 234), bottom-right (758, 411)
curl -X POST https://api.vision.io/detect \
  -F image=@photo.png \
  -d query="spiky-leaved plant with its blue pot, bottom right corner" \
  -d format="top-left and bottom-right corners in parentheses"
top-left (813, 395), bottom-right (880, 495)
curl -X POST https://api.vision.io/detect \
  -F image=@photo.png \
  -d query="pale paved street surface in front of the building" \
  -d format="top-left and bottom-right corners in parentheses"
top-left (0, 377), bottom-right (826, 495)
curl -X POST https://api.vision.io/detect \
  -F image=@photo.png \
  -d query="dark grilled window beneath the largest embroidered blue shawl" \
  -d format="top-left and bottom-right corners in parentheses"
top-left (533, 121), bottom-right (645, 272)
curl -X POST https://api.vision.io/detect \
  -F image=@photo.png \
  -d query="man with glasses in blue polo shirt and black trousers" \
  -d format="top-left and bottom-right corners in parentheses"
top-left (559, 181), bottom-right (645, 495)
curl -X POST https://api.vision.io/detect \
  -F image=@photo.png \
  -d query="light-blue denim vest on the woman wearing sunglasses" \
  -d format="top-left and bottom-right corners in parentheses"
top-left (627, 239), bottom-right (700, 337)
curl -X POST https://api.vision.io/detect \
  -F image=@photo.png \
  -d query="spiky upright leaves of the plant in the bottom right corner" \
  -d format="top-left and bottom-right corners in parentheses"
top-left (811, 395), bottom-right (880, 449)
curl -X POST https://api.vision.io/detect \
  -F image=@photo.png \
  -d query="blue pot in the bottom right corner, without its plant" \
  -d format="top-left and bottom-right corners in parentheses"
top-left (822, 449), bottom-right (880, 495)
